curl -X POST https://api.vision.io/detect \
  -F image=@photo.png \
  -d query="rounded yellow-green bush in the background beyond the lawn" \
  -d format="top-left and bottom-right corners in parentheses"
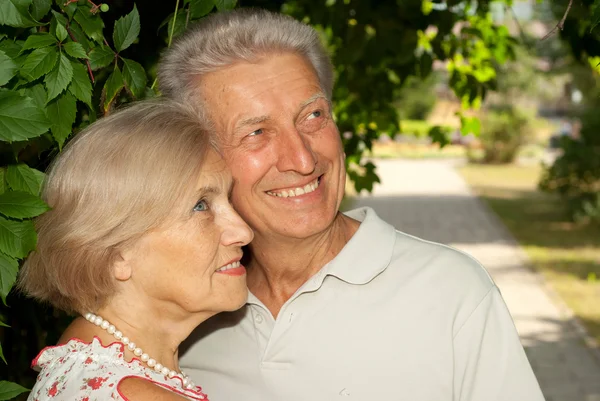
top-left (479, 105), bottom-right (529, 164)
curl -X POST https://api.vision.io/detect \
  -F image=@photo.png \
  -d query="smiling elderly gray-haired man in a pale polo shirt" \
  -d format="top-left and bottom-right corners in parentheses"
top-left (159, 10), bottom-right (543, 401)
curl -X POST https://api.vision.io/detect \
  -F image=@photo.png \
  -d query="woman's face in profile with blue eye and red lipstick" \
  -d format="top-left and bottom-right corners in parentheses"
top-left (123, 150), bottom-right (253, 315)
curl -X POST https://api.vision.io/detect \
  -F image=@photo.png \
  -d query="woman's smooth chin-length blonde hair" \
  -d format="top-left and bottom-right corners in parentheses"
top-left (18, 101), bottom-right (208, 313)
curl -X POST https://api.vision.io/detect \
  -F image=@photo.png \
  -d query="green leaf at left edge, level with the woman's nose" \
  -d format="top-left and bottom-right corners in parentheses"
top-left (0, 216), bottom-right (37, 259)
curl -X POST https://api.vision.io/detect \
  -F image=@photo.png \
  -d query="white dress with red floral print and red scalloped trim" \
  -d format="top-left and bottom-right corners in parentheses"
top-left (28, 337), bottom-right (208, 401)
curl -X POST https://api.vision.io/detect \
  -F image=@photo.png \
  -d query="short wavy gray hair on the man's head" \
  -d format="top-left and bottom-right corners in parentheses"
top-left (158, 9), bottom-right (333, 100)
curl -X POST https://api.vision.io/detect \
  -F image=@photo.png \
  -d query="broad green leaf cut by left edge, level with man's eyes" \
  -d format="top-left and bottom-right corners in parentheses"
top-left (0, 91), bottom-right (50, 142)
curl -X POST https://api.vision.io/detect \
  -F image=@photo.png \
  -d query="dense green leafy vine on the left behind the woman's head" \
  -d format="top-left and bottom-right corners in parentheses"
top-left (0, 0), bottom-right (236, 394)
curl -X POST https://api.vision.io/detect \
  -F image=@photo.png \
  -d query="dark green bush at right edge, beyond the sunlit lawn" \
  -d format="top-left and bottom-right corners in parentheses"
top-left (540, 104), bottom-right (600, 223)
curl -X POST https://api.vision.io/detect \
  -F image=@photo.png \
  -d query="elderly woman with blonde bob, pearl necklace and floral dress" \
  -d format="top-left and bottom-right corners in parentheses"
top-left (19, 102), bottom-right (253, 401)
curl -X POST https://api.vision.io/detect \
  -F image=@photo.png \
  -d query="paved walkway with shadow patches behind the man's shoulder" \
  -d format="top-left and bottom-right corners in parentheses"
top-left (344, 160), bottom-right (600, 401)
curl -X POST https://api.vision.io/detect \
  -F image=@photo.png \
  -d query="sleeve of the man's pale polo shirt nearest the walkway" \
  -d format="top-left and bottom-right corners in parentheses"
top-left (453, 286), bottom-right (544, 401)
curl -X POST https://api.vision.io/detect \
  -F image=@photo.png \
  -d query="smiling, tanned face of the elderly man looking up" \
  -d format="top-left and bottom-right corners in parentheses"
top-left (200, 53), bottom-right (346, 238)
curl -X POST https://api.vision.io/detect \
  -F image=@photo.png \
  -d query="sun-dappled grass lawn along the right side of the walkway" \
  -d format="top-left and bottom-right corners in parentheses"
top-left (460, 165), bottom-right (600, 342)
